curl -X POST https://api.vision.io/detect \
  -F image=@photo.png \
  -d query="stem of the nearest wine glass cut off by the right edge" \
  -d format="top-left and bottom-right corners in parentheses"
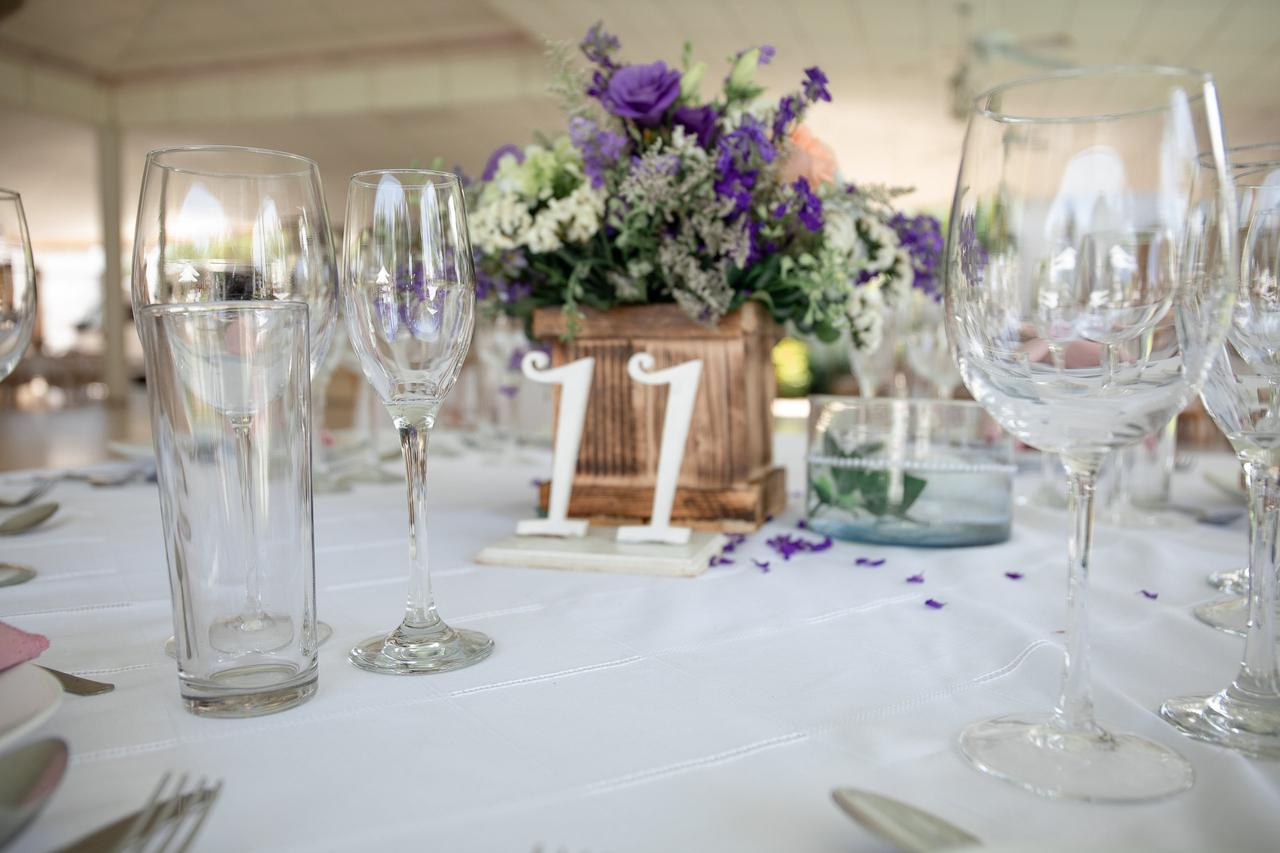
top-left (1233, 461), bottom-right (1280, 697)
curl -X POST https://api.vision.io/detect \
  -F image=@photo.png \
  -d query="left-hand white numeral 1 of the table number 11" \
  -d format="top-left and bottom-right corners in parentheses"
top-left (516, 350), bottom-right (595, 537)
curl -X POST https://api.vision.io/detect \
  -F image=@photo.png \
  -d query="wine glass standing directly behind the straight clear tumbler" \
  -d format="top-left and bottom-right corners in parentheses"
top-left (133, 145), bottom-right (338, 654)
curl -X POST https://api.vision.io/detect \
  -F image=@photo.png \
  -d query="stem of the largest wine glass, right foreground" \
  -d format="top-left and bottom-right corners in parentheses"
top-left (1055, 457), bottom-right (1098, 731)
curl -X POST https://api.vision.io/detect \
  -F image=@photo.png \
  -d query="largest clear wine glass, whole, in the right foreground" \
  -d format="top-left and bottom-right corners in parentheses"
top-left (946, 67), bottom-right (1236, 802)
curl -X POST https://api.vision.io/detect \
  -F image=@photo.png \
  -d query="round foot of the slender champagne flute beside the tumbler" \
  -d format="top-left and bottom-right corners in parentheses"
top-left (347, 620), bottom-right (493, 675)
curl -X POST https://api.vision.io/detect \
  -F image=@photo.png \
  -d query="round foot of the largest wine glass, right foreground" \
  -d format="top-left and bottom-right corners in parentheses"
top-left (960, 715), bottom-right (1196, 803)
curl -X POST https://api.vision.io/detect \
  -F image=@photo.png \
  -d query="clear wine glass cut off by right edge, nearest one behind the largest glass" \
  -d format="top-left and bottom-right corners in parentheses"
top-left (1160, 164), bottom-right (1280, 758)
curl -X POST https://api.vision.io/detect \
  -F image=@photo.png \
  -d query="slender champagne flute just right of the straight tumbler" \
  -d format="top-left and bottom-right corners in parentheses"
top-left (342, 169), bottom-right (493, 675)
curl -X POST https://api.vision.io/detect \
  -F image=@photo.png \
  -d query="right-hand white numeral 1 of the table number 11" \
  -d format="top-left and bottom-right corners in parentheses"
top-left (618, 352), bottom-right (703, 544)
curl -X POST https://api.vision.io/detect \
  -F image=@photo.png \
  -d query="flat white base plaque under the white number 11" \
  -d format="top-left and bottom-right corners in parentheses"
top-left (476, 526), bottom-right (728, 578)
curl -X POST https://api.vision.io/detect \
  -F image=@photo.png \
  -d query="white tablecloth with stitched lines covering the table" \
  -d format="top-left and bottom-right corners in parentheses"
top-left (0, 437), bottom-right (1280, 853)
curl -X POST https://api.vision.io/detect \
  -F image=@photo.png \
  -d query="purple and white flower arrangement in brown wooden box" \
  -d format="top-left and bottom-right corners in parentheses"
top-left (471, 24), bottom-right (941, 526)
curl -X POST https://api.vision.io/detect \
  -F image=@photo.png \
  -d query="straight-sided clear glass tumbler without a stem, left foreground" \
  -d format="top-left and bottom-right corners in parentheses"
top-left (141, 301), bottom-right (317, 717)
